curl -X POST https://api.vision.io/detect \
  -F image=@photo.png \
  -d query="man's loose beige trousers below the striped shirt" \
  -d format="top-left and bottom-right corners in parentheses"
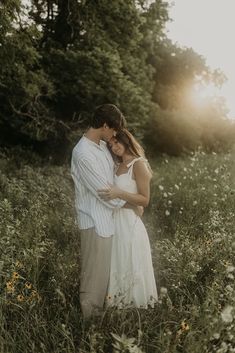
top-left (80, 228), bottom-right (112, 318)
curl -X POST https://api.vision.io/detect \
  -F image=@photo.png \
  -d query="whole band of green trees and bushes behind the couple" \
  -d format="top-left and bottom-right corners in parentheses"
top-left (0, 0), bottom-right (235, 158)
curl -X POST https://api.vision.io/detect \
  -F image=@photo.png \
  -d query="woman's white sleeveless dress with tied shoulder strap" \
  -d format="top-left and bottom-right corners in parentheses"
top-left (107, 157), bottom-right (158, 308)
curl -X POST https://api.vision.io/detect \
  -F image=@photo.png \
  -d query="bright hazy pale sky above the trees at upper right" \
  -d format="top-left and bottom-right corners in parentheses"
top-left (167, 0), bottom-right (235, 117)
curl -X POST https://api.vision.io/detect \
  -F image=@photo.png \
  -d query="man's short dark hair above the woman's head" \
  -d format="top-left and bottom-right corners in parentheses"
top-left (90, 104), bottom-right (126, 131)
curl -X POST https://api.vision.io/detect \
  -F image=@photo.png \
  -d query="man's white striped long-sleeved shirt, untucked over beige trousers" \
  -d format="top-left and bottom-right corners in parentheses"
top-left (71, 136), bottom-right (125, 237)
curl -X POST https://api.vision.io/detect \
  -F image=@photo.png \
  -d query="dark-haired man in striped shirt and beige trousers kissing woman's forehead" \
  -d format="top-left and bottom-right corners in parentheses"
top-left (71, 104), bottom-right (125, 318)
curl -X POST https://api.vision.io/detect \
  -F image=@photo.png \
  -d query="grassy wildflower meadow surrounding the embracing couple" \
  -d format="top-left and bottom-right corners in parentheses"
top-left (0, 149), bottom-right (235, 353)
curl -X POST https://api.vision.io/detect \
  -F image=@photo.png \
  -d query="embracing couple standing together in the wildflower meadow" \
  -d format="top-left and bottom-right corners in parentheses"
top-left (71, 104), bottom-right (157, 318)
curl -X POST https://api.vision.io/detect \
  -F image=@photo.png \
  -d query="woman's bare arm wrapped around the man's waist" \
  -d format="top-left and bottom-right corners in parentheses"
top-left (98, 161), bottom-right (151, 207)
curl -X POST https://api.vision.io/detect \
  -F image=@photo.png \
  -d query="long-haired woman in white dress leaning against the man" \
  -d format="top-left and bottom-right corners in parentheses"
top-left (99, 130), bottom-right (157, 308)
